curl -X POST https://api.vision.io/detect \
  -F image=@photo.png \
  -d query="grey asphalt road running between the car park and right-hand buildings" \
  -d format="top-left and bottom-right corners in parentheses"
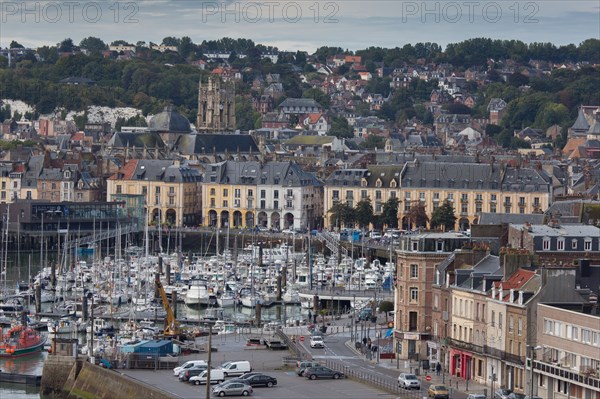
top-left (284, 317), bottom-right (491, 399)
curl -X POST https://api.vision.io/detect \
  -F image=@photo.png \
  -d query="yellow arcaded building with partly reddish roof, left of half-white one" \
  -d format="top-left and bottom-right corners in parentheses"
top-left (106, 159), bottom-right (202, 227)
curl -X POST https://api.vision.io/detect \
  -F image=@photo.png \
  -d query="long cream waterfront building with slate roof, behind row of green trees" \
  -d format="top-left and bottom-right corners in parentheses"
top-left (324, 160), bottom-right (553, 231)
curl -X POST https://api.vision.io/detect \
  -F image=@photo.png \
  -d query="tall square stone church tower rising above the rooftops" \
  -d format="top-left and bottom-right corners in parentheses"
top-left (197, 76), bottom-right (235, 133)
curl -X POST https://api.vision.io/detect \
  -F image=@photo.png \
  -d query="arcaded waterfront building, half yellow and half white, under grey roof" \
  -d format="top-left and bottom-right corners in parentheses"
top-left (202, 161), bottom-right (323, 229)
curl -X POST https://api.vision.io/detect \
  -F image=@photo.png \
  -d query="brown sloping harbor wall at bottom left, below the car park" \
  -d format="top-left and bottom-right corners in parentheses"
top-left (41, 356), bottom-right (177, 399)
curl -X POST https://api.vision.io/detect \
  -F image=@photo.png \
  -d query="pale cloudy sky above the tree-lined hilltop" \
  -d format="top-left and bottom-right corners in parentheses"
top-left (0, 0), bottom-right (600, 53)
